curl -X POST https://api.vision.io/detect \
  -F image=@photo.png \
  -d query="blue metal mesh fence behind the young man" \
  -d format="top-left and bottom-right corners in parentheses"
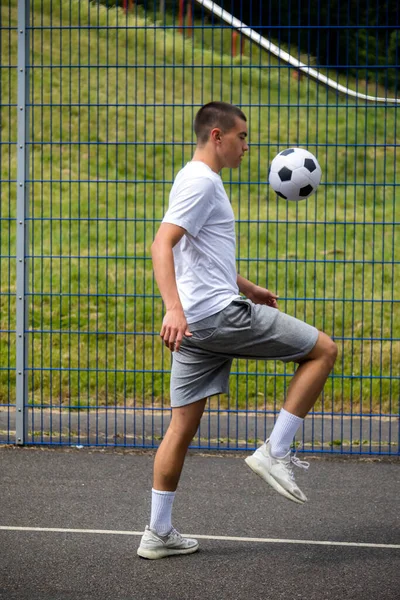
top-left (0, 0), bottom-right (400, 454)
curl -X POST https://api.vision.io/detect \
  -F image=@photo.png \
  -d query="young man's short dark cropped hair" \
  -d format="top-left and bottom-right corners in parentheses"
top-left (194, 102), bottom-right (247, 145)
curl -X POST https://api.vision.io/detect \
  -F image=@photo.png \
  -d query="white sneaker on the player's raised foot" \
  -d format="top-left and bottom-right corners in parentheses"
top-left (245, 439), bottom-right (310, 504)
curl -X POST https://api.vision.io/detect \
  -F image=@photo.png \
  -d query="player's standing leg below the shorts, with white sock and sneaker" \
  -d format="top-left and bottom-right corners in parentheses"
top-left (138, 399), bottom-right (206, 558)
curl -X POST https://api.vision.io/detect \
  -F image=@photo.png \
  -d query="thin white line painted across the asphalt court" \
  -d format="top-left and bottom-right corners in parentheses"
top-left (0, 525), bottom-right (400, 550)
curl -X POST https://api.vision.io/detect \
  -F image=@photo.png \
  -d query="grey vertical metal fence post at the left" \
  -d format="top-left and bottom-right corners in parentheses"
top-left (15, 0), bottom-right (29, 444)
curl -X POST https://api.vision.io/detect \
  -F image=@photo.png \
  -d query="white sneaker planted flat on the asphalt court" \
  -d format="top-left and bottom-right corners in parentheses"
top-left (137, 526), bottom-right (199, 559)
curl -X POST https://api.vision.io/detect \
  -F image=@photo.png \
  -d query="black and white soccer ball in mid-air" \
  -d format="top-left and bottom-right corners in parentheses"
top-left (269, 148), bottom-right (321, 202)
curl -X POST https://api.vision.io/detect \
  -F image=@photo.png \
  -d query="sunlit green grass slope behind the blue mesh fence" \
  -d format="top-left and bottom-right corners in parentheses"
top-left (0, 0), bottom-right (400, 413)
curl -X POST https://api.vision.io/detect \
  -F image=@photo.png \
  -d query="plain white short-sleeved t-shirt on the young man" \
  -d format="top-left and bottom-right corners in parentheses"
top-left (163, 161), bottom-right (239, 323)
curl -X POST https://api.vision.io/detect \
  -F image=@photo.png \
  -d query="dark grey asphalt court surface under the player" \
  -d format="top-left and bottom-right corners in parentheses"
top-left (0, 447), bottom-right (400, 600)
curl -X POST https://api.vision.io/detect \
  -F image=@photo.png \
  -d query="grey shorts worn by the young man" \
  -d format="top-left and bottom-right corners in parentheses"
top-left (171, 298), bottom-right (318, 407)
